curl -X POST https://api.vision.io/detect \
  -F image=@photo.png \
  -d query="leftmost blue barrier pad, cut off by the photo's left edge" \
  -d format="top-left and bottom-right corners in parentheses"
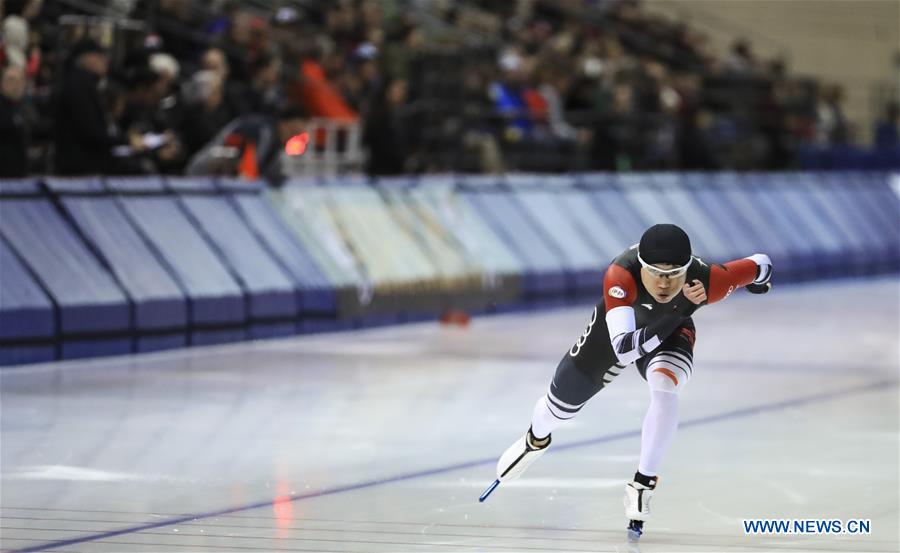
top-left (0, 240), bottom-right (56, 366)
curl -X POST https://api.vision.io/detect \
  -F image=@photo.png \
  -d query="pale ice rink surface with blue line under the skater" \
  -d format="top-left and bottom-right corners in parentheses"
top-left (0, 277), bottom-right (900, 553)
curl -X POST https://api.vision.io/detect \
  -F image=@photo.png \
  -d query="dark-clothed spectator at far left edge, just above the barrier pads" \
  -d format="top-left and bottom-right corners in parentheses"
top-left (0, 65), bottom-right (29, 177)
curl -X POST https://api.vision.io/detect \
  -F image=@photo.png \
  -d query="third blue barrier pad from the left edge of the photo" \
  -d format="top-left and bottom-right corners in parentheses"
top-left (45, 178), bottom-right (188, 351)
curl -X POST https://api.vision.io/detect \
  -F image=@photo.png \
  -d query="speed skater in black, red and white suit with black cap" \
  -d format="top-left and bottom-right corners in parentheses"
top-left (481, 224), bottom-right (772, 537)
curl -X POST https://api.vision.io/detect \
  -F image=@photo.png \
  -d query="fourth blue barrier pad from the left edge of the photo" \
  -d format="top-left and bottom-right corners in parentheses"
top-left (106, 178), bottom-right (247, 345)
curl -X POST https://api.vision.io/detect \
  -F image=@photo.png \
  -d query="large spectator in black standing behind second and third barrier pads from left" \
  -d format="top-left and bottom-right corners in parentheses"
top-left (55, 40), bottom-right (114, 175)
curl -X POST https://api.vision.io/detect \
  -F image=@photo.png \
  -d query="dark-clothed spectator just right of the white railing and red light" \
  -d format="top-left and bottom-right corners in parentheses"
top-left (363, 79), bottom-right (411, 176)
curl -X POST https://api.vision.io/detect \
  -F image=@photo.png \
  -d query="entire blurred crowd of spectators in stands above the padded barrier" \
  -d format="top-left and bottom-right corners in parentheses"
top-left (0, 0), bottom-right (898, 180)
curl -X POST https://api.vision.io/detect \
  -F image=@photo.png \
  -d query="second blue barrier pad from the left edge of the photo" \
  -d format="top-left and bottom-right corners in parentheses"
top-left (0, 179), bottom-right (132, 358)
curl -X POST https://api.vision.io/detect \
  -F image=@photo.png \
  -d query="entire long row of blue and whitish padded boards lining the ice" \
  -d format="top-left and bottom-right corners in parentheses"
top-left (0, 172), bottom-right (900, 365)
